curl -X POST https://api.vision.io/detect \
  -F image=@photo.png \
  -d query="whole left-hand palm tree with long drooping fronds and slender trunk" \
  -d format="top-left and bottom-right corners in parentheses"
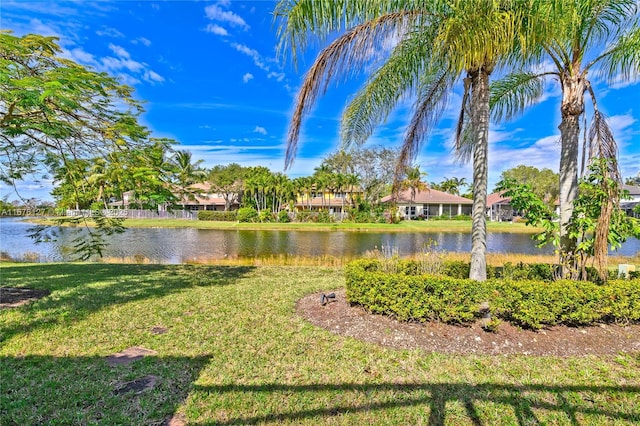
top-left (276, 0), bottom-right (527, 280)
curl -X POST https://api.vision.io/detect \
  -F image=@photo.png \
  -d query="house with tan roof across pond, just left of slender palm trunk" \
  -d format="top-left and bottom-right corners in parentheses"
top-left (382, 189), bottom-right (473, 219)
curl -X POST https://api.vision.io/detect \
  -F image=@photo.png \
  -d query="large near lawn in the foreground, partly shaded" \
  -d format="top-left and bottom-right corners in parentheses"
top-left (0, 264), bottom-right (640, 425)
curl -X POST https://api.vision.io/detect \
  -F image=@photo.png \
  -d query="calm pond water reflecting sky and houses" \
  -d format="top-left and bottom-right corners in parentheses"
top-left (0, 218), bottom-right (640, 263)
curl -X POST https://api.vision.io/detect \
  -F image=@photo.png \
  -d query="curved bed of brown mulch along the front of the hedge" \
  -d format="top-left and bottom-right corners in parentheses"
top-left (296, 289), bottom-right (640, 357)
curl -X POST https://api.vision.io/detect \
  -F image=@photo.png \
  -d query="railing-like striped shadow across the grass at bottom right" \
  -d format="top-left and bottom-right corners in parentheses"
top-left (194, 383), bottom-right (640, 426)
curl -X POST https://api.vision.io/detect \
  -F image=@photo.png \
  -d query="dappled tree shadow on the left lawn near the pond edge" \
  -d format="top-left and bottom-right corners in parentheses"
top-left (0, 263), bottom-right (255, 342)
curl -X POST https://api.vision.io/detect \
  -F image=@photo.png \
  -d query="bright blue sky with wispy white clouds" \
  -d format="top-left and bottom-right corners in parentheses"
top-left (0, 0), bottom-right (640, 200)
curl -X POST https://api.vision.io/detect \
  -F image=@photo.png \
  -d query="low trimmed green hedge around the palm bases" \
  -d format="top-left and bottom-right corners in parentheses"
top-left (346, 259), bottom-right (640, 330)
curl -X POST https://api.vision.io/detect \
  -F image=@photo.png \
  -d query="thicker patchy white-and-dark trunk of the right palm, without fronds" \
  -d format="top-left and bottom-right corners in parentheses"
top-left (558, 76), bottom-right (585, 278)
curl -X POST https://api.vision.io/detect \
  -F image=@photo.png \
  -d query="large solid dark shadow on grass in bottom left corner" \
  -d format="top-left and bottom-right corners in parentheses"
top-left (0, 356), bottom-right (209, 426)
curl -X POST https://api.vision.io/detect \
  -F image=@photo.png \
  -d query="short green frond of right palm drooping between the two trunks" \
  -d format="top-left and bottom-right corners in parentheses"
top-left (489, 72), bottom-right (548, 121)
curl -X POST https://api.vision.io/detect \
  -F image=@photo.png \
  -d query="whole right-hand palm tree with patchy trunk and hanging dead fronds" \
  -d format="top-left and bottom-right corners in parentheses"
top-left (492, 0), bottom-right (640, 274)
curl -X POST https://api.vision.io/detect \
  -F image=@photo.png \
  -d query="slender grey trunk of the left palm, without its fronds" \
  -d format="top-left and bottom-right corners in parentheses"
top-left (469, 68), bottom-right (489, 281)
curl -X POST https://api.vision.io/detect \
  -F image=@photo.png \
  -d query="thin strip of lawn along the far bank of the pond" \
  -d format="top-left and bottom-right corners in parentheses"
top-left (114, 219), bottom-right (541, 233)
